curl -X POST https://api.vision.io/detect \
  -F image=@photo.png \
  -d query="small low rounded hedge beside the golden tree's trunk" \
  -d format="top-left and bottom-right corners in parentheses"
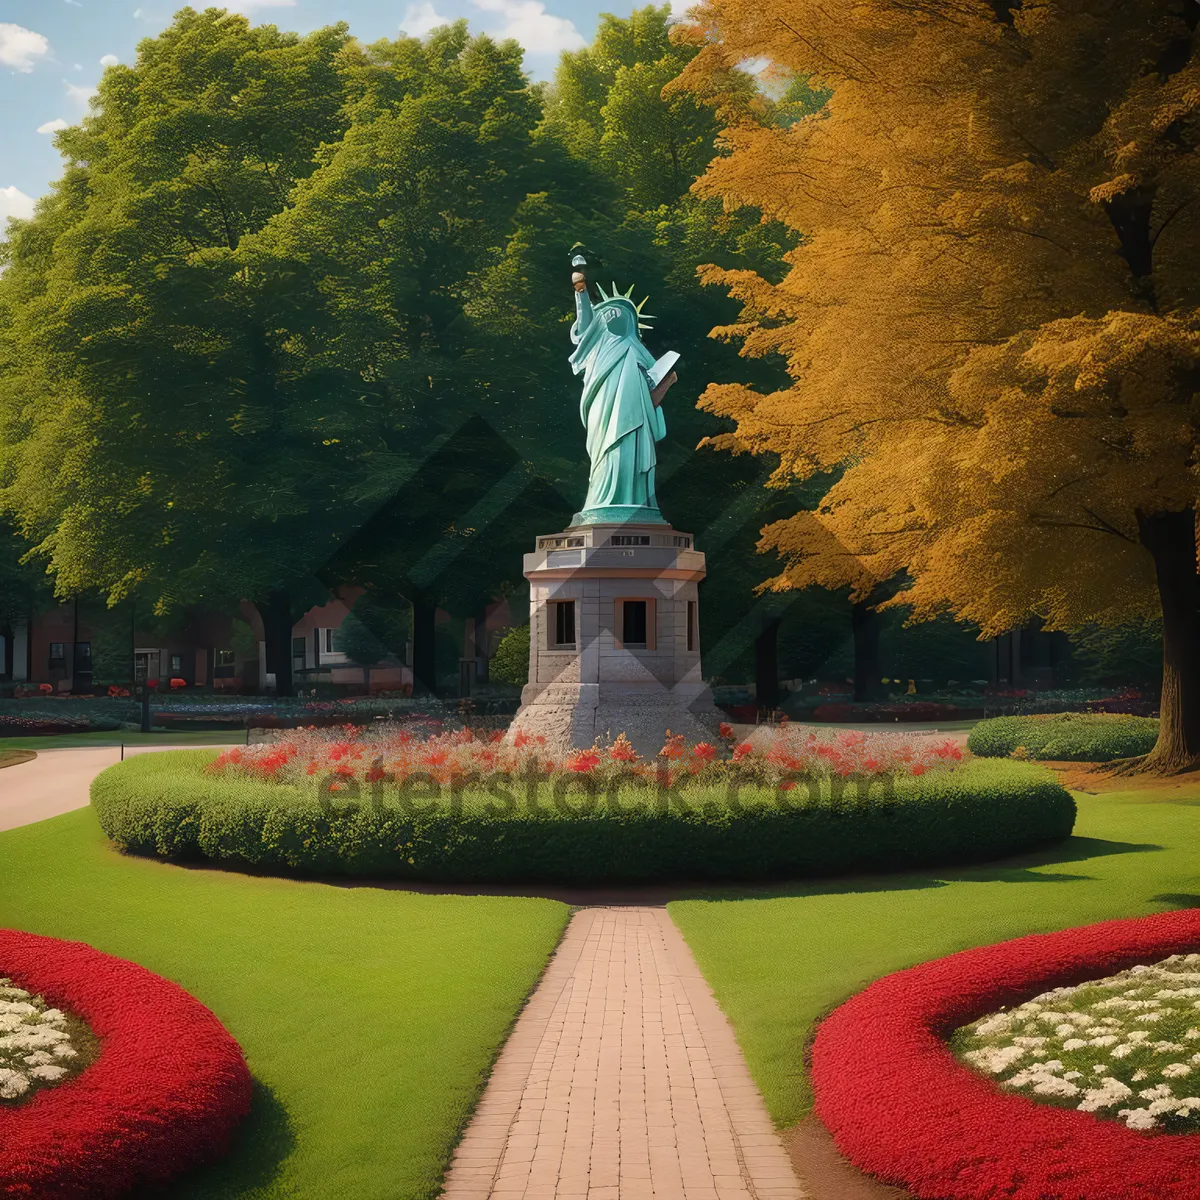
top-left (967, 713), bottom-right (1158, 762)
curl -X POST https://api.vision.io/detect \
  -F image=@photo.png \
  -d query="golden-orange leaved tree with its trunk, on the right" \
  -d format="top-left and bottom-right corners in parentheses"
top-left (673, 0), bottom-right (1200, 769)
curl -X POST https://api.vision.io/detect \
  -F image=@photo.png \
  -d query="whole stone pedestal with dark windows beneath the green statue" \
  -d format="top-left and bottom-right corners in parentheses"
top-left (509, 522), bottom-right (720, 757)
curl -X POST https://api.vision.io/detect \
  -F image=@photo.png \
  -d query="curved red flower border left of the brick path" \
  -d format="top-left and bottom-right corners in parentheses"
top-left (0, 930), bottom-right (251, 1200)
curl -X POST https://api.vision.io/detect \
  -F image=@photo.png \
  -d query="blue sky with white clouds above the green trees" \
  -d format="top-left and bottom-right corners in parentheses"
top-left (0, 0), bottom-right (692, 229)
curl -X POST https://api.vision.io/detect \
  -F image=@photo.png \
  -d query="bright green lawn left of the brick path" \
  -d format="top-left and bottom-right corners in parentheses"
top-left (0, 806), bottom-right (568, 1200)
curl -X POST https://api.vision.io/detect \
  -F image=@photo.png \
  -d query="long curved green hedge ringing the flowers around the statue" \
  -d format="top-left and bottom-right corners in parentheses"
top-left (91, 750), bottom-right (1075, 883)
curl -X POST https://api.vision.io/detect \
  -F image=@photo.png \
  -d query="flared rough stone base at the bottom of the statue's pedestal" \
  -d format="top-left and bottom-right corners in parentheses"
top-left (508, 684), bottom-right (722, 758)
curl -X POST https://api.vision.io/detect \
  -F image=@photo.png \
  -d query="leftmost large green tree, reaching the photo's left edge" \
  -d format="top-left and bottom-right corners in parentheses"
top-left (0, 8), bottom-right (355, 691)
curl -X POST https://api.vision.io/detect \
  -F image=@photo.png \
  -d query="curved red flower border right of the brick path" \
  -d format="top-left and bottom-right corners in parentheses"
top-left (812, 910), bottom-right (1200, 1200)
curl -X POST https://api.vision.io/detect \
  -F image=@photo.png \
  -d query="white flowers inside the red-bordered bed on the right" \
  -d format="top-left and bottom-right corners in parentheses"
top-left (953, 954), bottom-right (1200, 1133)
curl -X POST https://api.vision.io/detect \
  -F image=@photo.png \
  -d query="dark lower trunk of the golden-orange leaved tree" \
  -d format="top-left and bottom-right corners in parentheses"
top-left (1138, 508), bottom-right (1200, 773)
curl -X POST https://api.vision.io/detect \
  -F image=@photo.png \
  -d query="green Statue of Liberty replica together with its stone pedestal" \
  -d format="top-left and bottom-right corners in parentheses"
top-left (510, 238), bottom-right (719, 760)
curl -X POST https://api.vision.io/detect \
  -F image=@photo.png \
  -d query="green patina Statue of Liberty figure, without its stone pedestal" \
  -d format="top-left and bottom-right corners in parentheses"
top-left (571, 250), bottom-right (679, 524)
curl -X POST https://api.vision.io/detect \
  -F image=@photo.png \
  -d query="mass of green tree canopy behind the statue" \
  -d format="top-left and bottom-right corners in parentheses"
top-left (0, 5), bottom-right (974, 710)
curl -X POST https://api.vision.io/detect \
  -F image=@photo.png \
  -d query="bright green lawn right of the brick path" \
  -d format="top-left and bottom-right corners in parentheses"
top-left (670, 785), bottom-right (1200, 1126)
